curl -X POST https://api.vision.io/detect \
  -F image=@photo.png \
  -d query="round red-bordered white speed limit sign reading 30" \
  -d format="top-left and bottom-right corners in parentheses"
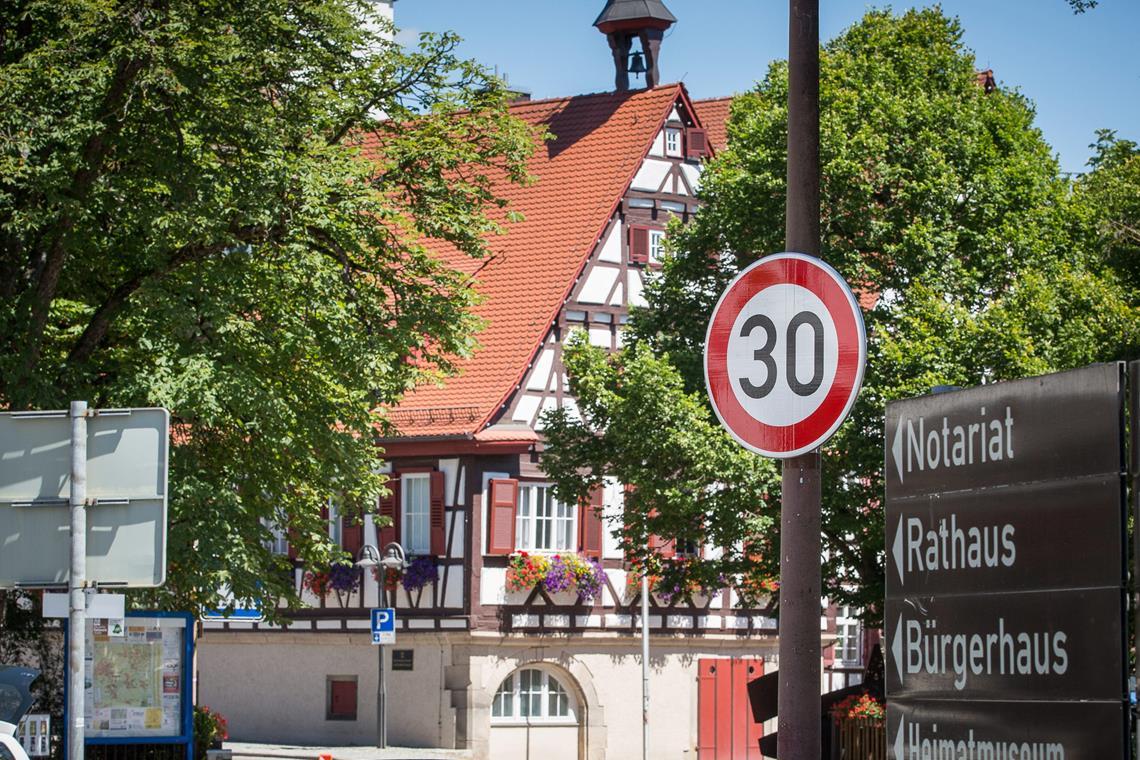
top-left (705, 253), bottom-right (866, 459)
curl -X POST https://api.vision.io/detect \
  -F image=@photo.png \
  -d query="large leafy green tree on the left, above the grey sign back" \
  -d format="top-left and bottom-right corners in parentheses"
top-left (0, 0), bottom-right (532, 610)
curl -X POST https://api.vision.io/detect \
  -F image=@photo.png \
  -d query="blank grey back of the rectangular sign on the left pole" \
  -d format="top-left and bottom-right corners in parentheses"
top-left (0, 409), bottom-right (170, 588)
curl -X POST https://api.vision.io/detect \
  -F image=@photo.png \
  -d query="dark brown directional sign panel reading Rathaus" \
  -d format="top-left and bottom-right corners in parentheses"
top-left (886, 474), bottom-right (1124, 598)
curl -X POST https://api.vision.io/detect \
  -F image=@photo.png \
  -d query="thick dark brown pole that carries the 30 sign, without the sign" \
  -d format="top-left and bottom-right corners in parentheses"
top-left (776, 0), bottom-right (822, 760)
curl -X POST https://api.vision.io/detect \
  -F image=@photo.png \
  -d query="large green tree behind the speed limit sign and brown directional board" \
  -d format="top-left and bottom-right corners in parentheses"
top-left (552, 9), bottom-right (1138, 620)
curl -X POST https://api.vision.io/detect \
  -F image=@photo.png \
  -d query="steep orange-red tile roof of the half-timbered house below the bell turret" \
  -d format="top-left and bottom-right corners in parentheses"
top-left (391, 84), bottom-right (687, 436)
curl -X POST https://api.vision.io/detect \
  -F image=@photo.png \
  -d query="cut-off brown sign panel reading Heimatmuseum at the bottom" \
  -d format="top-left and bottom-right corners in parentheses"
top-left (887, 700), bottom-right (1127, 760)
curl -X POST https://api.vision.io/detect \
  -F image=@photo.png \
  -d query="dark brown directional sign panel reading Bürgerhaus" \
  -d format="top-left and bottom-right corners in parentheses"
top-left (884, 588), bottom-right (1124, 700)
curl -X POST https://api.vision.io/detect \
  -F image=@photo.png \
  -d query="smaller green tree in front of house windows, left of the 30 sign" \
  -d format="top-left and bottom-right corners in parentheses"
top-left (543, 333), bottom-right (780, 599)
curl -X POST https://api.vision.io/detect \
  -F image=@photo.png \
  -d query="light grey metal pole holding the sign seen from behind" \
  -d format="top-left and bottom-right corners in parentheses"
top-left (67, 401), bottom-right (88, 760)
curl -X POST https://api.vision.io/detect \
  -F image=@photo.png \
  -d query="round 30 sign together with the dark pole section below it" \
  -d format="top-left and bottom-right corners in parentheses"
top-left (705, 253), bottom-right (866, 760)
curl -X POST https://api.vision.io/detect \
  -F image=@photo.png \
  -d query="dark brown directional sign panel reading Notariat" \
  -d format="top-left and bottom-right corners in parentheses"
top-left (885, 363), bottom-right (1124, 500)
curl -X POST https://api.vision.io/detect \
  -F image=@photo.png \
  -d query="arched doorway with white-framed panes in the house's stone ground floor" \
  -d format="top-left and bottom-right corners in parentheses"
top-left (490, 663), bottom-right (583, 760)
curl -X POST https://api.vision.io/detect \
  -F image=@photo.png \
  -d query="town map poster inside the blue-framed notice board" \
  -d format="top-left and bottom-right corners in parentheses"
top-left (83, 618), bottom-right (187, 738)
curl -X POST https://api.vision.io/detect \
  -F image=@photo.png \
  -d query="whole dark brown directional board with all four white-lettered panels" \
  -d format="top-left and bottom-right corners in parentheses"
top-left (884, 363), bottom-right (1135, 760)
